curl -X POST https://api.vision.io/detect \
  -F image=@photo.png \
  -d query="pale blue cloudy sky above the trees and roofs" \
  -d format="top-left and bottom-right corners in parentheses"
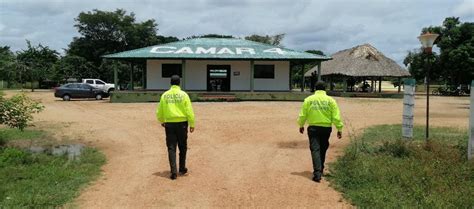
top-left (0, 0), bottom-right (474, 65)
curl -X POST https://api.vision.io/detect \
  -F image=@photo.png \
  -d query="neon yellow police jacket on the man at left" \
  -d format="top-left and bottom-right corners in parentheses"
top-left (156, 85), bottom-right (194, 127)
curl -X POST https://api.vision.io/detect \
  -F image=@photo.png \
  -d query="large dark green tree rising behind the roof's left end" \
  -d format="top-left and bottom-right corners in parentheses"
top-left (66, 9), bottom-right (178, 81)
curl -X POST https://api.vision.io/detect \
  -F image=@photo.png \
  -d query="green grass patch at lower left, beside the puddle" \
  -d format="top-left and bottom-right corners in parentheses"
top-left (0, 129), bottom-right (105, 208)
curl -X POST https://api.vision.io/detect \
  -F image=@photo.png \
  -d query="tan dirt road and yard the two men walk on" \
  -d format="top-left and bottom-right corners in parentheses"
top-left (9, 92), bottom-right (469, 208)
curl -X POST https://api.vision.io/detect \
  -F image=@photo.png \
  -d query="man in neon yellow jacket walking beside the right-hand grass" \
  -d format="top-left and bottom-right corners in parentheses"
top-left (298, 81), bottom-right (344, 182)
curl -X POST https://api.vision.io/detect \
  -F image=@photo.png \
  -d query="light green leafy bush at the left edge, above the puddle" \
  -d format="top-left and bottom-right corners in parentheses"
top-left (0, 94), bottom-right (44, 131)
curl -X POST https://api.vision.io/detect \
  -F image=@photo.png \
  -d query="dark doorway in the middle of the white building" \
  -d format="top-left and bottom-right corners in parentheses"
top-left (207, 65), bottom-right (230, 91)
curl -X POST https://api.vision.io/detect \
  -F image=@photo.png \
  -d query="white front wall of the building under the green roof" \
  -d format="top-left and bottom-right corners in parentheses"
top-left (147, 60), bottom-right (290, 91)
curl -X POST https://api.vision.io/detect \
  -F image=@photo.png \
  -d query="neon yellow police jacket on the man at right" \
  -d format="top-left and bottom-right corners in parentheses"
top-left (298, 91), bottom-right (344, 131)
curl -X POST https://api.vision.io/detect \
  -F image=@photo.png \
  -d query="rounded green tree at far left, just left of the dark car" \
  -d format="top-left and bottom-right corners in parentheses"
top-left (17, 40), bottom-right (59, 91)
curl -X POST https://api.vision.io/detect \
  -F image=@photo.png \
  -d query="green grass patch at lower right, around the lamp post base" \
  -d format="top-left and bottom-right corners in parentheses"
top-left (329, 125), bottom-right (474, 208)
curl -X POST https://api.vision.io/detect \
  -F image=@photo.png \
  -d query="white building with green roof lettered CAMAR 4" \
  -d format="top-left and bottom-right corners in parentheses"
top-left (104, 38), bottom-right (331, 91)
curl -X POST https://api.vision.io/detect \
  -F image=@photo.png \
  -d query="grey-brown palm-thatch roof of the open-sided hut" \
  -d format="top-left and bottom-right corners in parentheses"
top-left (305, 44), bottom-right (410, 77)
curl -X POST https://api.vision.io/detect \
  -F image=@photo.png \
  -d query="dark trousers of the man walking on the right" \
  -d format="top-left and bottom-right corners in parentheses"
top-left (308, 126), bottom-right (332, 177)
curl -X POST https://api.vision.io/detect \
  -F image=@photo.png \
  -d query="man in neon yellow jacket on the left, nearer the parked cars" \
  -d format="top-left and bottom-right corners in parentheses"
top-left (156, 75), bottom-right (194, 180)
